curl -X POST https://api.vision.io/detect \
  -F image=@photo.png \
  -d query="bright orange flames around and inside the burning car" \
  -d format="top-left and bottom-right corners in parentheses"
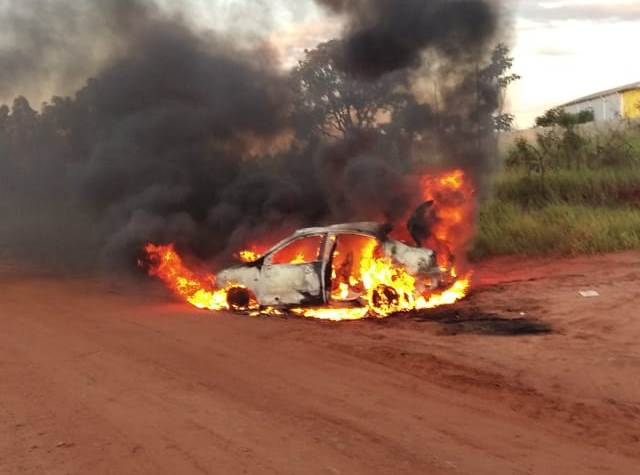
top-left (145, 170), bottom-right (474, 321)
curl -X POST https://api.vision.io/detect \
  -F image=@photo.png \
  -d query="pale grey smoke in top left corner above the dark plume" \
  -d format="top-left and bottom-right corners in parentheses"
top-left (0, 0), bottom-right (151, 102)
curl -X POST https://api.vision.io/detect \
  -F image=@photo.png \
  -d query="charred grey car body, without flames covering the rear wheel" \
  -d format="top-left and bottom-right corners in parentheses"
top-left (217, 222), bottom-right (446, 308)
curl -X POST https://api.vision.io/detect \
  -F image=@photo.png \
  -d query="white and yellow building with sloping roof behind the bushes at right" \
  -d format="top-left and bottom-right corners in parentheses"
top-left (560, 81), bottom-right (640, 122)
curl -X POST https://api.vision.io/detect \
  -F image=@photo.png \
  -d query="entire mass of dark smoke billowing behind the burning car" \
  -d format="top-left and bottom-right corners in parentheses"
top-left (0, 0), bottom-right (495, 269)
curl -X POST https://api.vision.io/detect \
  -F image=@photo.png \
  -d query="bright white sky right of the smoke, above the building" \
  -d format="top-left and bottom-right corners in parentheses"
top-left (511, 0), bottom-right (640, 127)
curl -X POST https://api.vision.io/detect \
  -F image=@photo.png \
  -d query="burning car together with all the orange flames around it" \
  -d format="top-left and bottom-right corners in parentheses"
top-left (145, 170), bottom-right (473, 321)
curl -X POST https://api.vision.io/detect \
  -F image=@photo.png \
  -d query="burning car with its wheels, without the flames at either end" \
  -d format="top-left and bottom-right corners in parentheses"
top-left (217, 222), bottom-right (450, 316)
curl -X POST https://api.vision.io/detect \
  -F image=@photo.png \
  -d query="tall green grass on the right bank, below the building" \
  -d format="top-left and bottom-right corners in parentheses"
top-left (471, 126), bottom-right (640, 258)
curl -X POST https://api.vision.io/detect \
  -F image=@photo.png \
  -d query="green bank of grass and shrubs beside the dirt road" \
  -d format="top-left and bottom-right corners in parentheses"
top-left (471, 123), bottom-right (640, 258)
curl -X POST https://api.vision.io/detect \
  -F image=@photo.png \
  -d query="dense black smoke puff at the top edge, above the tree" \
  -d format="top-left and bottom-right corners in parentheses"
top-left (319, 0), bottom-right (497, 78)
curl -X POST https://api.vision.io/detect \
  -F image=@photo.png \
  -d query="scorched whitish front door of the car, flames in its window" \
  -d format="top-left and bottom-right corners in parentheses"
top-left (259, 234), bottom-right (326, 306)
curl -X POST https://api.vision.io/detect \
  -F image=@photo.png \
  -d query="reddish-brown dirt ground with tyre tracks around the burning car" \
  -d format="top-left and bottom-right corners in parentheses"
top-left (0, 253), bottom-right (640, 475)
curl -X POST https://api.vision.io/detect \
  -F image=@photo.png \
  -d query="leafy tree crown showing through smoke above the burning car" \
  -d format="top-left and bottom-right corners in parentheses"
top-left (292, 40), bottom-right (404, 138)
